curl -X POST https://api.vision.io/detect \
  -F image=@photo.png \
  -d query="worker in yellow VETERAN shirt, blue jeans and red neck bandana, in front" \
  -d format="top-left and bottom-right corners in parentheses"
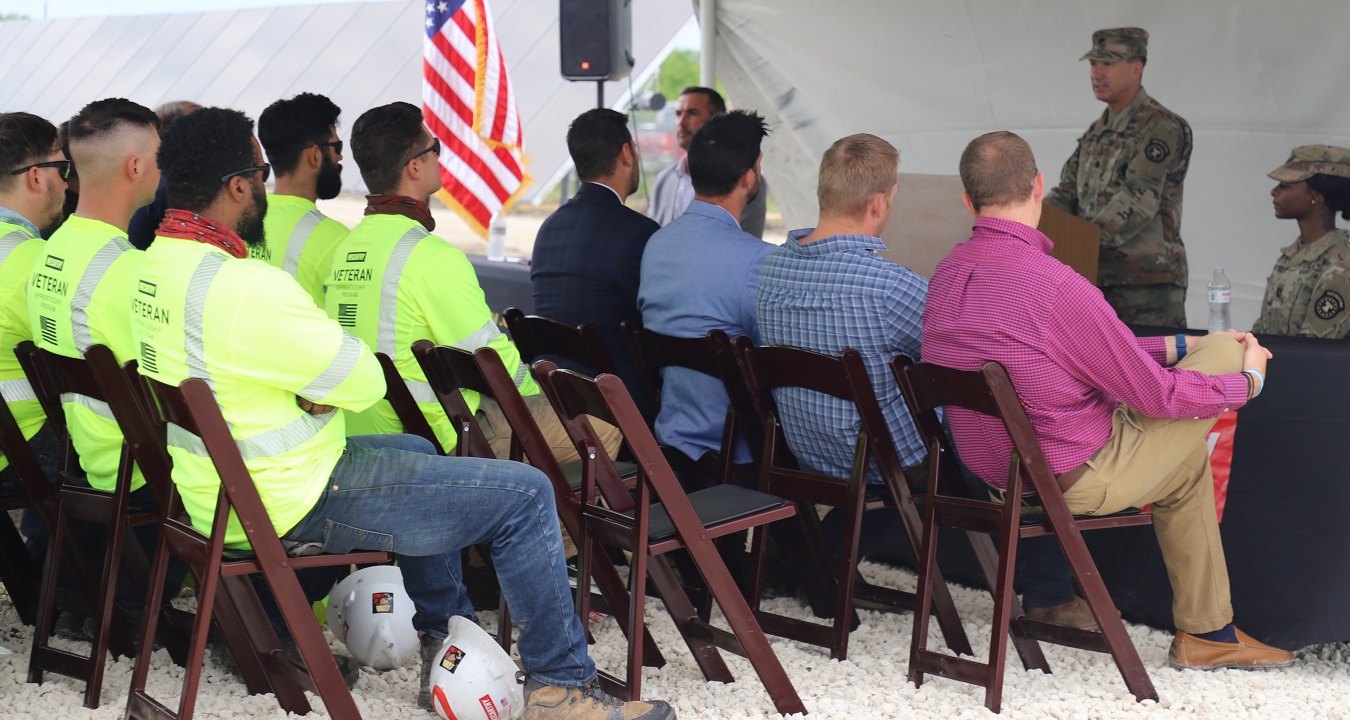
top-left (132, 108), bottom-right (675, 720)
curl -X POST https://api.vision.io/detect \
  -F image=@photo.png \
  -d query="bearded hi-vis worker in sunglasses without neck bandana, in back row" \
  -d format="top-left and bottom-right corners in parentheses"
top-left (248, 92), bottom-right (347, 308)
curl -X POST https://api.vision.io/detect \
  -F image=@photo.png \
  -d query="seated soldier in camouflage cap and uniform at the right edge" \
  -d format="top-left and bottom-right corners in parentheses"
top-left (1251, 145), bottom-right (1350, 338)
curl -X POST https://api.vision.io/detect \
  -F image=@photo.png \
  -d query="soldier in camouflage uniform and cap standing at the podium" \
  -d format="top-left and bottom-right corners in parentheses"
top-left (1046, 27), bottom-right (1191, 328)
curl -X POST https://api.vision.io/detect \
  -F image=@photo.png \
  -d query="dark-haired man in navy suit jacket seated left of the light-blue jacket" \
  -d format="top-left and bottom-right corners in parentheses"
top-left (529, 108), bottom-right (660, 420)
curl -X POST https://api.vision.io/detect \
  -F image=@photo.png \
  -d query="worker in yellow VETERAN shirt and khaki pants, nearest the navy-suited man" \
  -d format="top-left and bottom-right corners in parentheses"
top-left (324, 103), bottom-right (620, 462)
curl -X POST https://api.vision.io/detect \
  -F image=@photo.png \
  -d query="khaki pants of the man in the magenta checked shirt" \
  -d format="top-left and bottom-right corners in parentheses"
top-left (1064, 336), bottom-right (1242, 634)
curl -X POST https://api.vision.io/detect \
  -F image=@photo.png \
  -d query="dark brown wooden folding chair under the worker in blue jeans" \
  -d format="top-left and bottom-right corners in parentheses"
top-left (126, 378), bottom-right (392, 720)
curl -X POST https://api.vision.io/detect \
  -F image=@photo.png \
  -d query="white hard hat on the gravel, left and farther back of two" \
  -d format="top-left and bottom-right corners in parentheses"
top-left (328, 565), bottom-right (419, 670)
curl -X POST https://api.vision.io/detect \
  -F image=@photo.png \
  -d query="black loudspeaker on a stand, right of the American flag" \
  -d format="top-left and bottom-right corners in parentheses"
top-left (558, 0), bottom-right (633, 80)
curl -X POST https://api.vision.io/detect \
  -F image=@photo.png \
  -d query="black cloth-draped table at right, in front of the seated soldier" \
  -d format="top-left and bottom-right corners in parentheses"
top-left (878, 332), bottom-right (1350, 650)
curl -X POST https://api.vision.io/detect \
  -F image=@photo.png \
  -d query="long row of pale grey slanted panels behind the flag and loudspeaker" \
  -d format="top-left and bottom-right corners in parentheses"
top-left (0, 0), bottom-right (691, 200)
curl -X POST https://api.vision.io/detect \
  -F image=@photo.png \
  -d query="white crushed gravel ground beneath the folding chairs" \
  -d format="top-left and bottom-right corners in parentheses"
top-left (0, 566), bottom-right (1350, 720)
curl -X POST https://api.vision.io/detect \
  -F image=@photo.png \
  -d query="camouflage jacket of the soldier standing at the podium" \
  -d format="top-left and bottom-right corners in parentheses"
top-left (1046, 88), bottom-right (1191, 288)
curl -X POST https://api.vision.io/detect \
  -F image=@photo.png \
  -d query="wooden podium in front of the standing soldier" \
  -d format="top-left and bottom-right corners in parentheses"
top-left (882, 173), bottom-right (1102, 285)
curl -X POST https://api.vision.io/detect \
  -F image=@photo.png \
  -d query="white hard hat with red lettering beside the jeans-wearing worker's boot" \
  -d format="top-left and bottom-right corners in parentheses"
top-left (431, 616), bottom-right (525, 720)
